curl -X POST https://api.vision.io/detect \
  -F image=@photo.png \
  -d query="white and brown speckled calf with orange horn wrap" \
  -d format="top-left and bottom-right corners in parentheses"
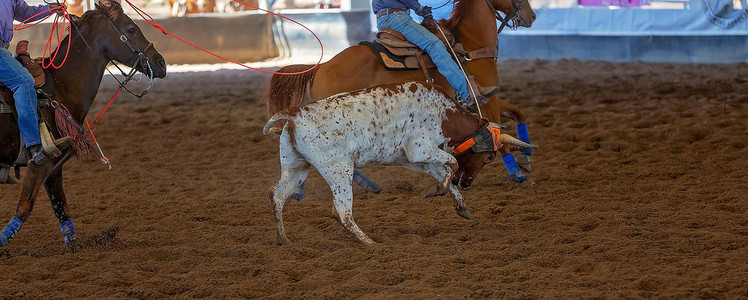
top-left (264, 82), bottom-right (531, 244)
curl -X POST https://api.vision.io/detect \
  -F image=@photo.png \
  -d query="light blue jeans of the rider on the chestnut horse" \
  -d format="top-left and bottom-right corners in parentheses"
top-left (377, 11), bottom-right (470, 99)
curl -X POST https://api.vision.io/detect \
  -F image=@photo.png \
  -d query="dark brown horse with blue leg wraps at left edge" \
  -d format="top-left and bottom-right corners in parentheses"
top-left (0, 1), bottom-right (166, 246)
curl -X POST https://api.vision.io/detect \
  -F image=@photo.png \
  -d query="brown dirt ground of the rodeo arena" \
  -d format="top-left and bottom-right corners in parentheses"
top-left (0, 60), bottom-right (748, 299)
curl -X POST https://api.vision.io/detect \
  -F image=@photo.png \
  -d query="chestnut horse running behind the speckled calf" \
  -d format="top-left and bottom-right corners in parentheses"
top-left (265, 0), bottom-right (535, 186)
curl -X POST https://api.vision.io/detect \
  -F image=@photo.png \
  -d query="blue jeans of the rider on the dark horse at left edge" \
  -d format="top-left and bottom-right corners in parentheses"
top-left (0, 47), bottom-right (42, 147)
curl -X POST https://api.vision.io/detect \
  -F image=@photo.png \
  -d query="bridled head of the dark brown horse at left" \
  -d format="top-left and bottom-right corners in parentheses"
top-left (90, 0), bottom-right (166, 78)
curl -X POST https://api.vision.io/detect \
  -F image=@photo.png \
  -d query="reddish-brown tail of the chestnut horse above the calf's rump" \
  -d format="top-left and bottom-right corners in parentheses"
top-left (263, 65), bottom-right (318, 117)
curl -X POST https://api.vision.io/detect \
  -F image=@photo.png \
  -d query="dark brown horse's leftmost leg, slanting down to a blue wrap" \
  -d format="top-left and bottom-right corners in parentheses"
top-left (0, 162), bottom-right (52, 247)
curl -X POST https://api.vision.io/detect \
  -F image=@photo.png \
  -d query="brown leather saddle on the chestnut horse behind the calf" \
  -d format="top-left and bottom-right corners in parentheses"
top-left (359, 20), bottom-right (499, 81)
